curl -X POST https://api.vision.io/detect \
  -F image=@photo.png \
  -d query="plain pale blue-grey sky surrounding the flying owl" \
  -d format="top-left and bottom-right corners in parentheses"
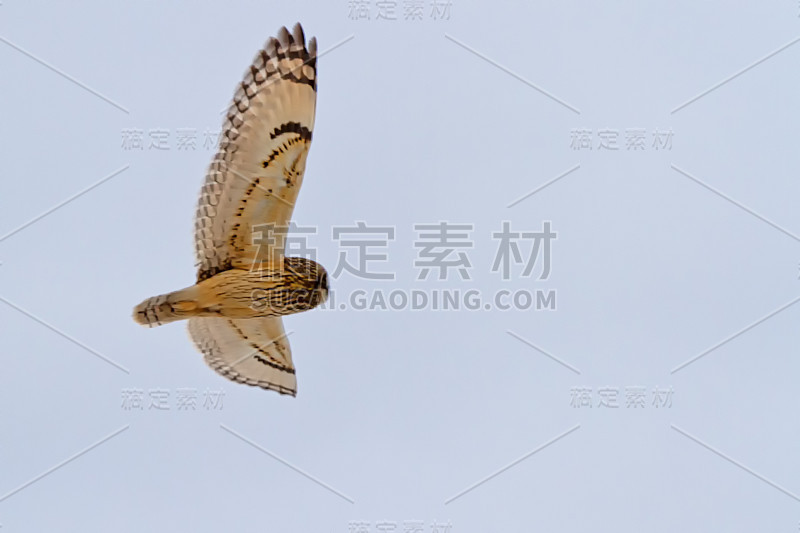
top-left (0, 0), bottom-right (800, 533)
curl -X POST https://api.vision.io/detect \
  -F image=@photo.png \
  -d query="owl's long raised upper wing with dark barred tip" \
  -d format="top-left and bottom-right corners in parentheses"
top-left (195, 24), bottom-right (317, 281)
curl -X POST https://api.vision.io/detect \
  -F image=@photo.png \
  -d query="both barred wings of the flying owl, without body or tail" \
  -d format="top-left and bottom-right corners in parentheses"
top-left (189, 24), bottom-right (317, 396)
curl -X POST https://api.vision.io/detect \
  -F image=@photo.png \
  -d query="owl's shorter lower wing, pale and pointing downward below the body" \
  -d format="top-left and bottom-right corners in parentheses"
top-left (189, 317), bottom-right (297, 396)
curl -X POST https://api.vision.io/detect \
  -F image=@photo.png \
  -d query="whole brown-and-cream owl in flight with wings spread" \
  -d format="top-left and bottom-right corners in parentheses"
top-left (133, 24), bottom-right (328, 396)
